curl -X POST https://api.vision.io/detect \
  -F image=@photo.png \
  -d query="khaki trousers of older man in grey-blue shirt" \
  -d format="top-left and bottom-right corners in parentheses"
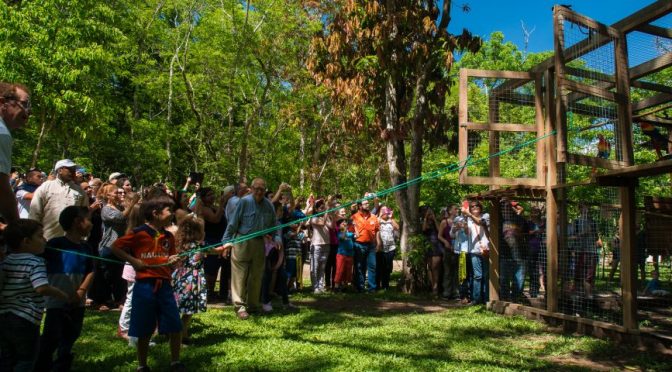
top-left (231, 237), bottom-right (265, 311)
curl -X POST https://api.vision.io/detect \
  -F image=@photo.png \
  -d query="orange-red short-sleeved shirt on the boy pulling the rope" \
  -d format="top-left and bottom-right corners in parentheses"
top-left (112, 224), bottom-right (177, 280)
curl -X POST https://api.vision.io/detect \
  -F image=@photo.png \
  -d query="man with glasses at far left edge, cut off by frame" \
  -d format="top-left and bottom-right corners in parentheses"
top-left (0, 82), bottom-right (30, 230)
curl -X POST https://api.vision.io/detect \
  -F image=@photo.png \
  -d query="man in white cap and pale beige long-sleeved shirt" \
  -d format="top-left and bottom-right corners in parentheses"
top-left (30, 159), bottom-right (89, 240)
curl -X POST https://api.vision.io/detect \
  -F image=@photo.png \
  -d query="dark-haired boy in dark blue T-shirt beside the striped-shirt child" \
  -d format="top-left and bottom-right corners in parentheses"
top-left (35, 205), bottom-right (93, 371)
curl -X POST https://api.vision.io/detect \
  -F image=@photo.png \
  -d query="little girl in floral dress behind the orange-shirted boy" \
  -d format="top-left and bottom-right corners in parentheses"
top-left (173, 214), bottom-right (222, 345)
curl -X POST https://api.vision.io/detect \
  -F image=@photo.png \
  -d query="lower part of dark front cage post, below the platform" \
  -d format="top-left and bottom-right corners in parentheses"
top-left (620, 186), bottom-right (638, 329)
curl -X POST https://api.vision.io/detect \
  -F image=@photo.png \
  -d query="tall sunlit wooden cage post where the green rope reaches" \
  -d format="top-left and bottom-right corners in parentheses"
top-left (544, 69), bottom-right (558, 312)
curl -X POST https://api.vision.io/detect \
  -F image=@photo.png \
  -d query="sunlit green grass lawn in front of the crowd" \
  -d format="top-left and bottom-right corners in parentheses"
top-left (73, 292), bottom-right (672, 371)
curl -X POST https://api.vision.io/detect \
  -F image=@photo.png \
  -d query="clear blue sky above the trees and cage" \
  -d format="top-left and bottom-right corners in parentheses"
top-left (448, 0), bottom-right (655, 52)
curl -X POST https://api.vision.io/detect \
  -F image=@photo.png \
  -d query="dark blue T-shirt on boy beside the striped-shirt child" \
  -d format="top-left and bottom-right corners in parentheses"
top-left (44, 236), bottom-right (93, 309)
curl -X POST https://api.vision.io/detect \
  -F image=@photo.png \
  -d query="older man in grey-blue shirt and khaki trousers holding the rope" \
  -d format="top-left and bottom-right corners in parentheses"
top-left (222, 178), bottom-right (282, 320)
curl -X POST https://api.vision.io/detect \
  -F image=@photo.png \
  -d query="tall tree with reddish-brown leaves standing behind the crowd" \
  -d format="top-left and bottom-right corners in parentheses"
top-left (308, 0), bottom-right (481, 290)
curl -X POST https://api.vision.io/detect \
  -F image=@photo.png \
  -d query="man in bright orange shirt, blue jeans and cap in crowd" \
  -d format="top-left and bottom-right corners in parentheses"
top-left (352, 199), bottom-right (380, 292)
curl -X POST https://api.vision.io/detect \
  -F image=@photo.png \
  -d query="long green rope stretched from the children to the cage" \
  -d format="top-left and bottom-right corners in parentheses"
top-left (47, 129), bottom-right (556, 267)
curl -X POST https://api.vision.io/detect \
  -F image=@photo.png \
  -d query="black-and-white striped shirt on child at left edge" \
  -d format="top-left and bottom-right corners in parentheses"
top-left (0, 253), bottom-right (49, 325)
